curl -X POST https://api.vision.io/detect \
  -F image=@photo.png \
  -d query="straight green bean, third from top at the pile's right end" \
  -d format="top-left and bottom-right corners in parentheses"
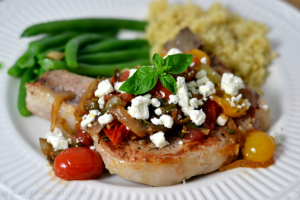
top-left (78, 48), bottom-right (150, 64)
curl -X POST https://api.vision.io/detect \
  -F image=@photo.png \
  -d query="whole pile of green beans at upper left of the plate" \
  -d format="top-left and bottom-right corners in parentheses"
top-left (8, 19), bottom-right (150, 116)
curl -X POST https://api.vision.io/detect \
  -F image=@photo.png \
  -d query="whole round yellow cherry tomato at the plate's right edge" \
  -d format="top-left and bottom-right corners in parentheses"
top-left (242, 131), bottom-right (275, 162)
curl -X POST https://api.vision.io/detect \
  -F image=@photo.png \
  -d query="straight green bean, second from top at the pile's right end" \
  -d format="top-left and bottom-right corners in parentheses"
top-left (80, 39), bottom-right (149, 54)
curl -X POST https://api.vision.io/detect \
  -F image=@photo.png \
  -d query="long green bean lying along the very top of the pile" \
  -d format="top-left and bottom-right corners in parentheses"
top-left (21, 18), bottom-right (147, 37)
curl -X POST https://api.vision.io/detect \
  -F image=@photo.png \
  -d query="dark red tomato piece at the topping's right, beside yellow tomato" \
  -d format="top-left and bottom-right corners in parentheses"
top-left (203, 100), bottom-right (220, 130)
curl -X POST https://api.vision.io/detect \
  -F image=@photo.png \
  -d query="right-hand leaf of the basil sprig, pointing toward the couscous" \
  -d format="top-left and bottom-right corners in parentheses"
top-left (164, 54), bottom-right (193, 74)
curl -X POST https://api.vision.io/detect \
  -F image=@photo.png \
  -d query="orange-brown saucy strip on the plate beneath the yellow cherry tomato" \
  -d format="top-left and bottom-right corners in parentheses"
top-left (219, 157), bottom-right (275, 172)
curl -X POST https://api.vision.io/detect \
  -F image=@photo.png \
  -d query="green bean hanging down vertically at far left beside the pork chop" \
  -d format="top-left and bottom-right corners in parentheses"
top-left (18, 67), bottom-right (34, 116)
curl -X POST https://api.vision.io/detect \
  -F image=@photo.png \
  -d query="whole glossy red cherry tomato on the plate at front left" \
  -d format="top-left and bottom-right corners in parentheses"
top-left (54, 147), bottom-right (104, 180)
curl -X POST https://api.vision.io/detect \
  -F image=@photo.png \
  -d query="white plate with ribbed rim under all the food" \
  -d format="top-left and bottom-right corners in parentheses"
top-left (0, 0), bottom-right (300, 200)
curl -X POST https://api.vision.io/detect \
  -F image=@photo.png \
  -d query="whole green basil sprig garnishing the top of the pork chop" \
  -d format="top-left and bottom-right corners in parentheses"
top-left (119, 53), bottom-right (193, 94)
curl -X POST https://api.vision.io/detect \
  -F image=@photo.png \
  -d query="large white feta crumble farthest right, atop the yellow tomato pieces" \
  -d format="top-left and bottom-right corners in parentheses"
top-left (221, 73), bottom-right (244, 96)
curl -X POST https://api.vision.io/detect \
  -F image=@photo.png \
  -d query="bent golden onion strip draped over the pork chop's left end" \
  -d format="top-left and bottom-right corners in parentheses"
top-left (51, 91), bottom-right (75, 131)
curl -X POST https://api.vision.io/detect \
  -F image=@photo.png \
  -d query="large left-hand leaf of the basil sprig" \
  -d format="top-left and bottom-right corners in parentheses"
top-left (119, 67), bottom-right (158, 94)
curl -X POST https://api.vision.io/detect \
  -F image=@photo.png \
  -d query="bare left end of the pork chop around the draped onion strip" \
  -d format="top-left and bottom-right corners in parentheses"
top-left (26, 70), bottom-right (94, 130)
